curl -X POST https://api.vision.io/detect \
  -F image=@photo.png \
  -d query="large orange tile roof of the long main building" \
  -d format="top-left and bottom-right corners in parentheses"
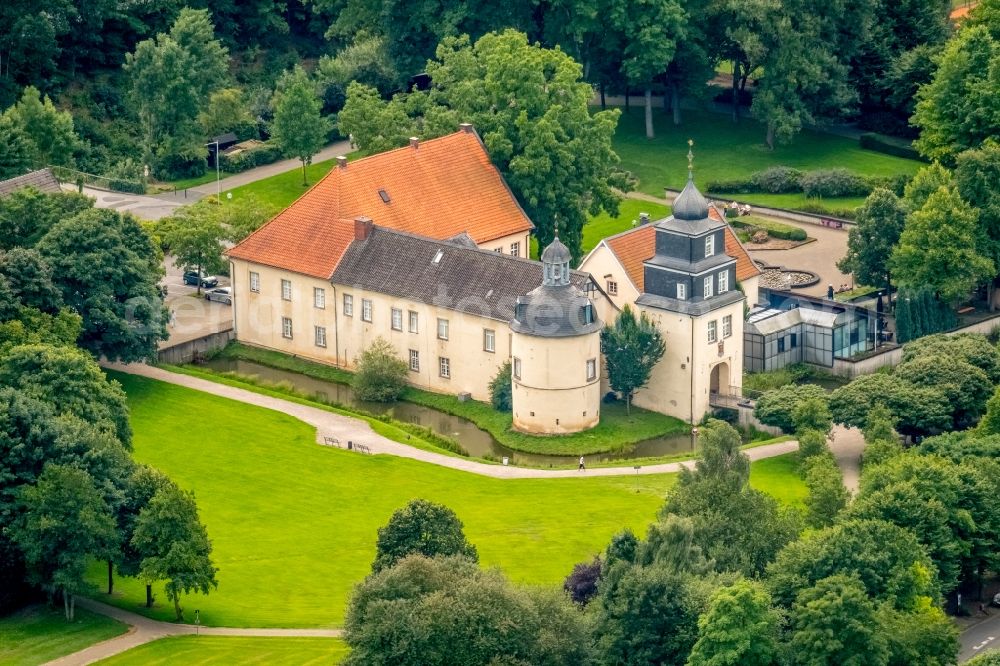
top-left (229, 128), bottom-right (534, 278)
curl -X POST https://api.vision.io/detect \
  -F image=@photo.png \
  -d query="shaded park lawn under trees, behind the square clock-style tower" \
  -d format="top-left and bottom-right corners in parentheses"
top-left (614, 107), bottom-right (922, 208)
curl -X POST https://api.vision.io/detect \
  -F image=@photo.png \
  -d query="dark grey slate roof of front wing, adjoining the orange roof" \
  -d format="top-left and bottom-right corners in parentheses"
top-left (330, 226), bottom-right (592, 322)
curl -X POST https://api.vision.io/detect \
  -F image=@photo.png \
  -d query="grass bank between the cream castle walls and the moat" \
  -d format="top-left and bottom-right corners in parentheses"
top-left (198, 343), bottom-right (689, 455)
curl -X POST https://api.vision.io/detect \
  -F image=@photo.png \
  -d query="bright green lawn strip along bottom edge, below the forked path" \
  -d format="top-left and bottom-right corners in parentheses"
top-left (97, 636), bottom-right (348, 666)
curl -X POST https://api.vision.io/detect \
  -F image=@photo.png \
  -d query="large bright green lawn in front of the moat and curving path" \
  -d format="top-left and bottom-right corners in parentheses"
top-left (91, 376), bottom-right (802, 627)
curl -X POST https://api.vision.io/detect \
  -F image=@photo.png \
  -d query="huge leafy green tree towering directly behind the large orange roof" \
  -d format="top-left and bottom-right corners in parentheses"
top-left (338, 30), bottom-right (631, 259)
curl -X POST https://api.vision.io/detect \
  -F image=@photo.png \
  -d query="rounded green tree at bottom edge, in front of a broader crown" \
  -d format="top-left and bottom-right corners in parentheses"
top-left (790, 575), bottom-right (888, 666)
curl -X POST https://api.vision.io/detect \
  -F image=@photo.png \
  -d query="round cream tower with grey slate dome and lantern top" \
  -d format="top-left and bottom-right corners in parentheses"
top-left (510, 238), bottom-right (603, 434)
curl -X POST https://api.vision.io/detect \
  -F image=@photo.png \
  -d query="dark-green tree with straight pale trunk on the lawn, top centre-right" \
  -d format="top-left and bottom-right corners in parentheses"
top-left (607, 0), bottom-right (687, 139)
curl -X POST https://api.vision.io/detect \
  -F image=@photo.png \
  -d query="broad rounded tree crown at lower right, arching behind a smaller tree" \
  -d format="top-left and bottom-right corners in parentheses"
top-left (767, 520), bottom-right (940, 609)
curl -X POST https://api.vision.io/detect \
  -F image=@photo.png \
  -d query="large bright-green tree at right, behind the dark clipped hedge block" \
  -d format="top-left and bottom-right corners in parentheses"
top-left (889, 187), bottom-right (996, 303)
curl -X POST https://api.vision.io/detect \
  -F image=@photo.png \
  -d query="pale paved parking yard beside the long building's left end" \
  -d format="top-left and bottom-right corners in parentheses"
top-left (160, 256), bottom-right (233, 349)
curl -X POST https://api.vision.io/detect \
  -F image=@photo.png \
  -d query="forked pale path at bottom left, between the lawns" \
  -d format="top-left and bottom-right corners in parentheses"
top-left (48, 597), bottom-right (344, 666)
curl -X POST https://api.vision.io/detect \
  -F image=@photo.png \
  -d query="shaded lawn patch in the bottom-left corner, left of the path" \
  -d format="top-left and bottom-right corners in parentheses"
top-left (0, 605), bottom-right (128, 666)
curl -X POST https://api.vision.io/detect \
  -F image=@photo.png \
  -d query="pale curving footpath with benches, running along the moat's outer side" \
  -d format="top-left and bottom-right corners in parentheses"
top-left (105, 363), bottom-right (799, 479)
